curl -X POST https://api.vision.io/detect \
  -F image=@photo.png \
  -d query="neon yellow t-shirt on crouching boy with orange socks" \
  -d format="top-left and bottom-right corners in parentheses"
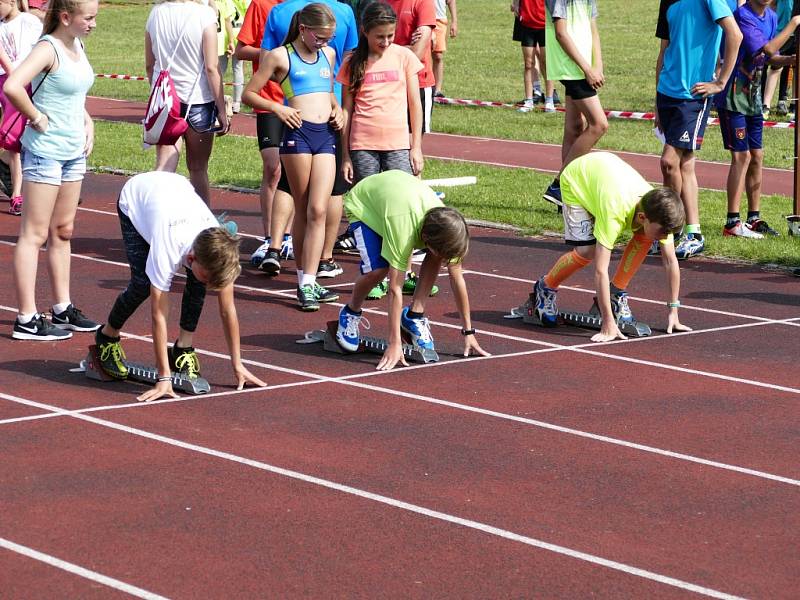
top-left (561, 152), bottom-right (653, 249)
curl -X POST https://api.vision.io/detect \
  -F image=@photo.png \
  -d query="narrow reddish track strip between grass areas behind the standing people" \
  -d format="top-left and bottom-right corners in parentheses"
top-left (86, 97), bottom-right (793, 197)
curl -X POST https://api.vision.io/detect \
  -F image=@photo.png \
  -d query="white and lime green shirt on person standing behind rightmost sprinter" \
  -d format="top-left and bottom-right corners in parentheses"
top-left (544, 0), bottom-right (597, 81)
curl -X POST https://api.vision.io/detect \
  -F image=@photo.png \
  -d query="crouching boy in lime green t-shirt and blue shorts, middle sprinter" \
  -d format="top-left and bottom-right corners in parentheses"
top-left (336, 170), bottom-right (488, 371)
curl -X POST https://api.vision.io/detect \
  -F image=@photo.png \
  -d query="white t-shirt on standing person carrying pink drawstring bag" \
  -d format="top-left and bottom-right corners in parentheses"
top-left (145, 2), bottom-right (217, 104)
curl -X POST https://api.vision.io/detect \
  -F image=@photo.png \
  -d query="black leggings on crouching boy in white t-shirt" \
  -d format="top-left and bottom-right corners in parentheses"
top-left (108, 203), bottom-right (206, 332)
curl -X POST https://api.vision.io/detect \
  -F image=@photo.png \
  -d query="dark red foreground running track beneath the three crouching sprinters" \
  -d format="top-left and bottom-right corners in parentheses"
top-left (0, 175), bottom-right (800, 598)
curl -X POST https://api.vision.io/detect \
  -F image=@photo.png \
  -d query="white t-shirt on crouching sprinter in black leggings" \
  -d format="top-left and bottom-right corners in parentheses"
top-left (119, 171), bottom-right (219, 292)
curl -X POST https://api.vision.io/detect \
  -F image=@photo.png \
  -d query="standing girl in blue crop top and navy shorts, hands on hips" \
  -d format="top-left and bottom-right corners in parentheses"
top-left (242, 3), bottom-right (344, 311)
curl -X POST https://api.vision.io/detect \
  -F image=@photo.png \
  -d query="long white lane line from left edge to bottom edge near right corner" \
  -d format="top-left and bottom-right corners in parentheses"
top-left (0, 392), bottom-right (752, 599)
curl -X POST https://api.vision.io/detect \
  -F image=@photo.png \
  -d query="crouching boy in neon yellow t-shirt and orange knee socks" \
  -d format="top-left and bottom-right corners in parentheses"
top-left (531, 152), bottom-right (690, 342)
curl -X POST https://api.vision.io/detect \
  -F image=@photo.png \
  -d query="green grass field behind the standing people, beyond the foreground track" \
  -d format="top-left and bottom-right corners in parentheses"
top-left (86, 0), bottom-right (798, 264)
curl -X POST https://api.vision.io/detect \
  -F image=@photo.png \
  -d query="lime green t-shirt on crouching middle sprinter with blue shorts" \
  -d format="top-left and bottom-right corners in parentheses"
top-left (344, 171), bottom-right (444, 271)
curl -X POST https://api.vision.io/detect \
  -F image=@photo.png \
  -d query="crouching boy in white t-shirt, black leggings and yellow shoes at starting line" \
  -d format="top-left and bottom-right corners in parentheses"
top-left (96, 171), bottom-right (266, 401)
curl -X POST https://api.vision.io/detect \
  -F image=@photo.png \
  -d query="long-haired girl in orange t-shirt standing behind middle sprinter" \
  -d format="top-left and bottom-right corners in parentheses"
top-left (337, 2), bottom-right (423, 183)
